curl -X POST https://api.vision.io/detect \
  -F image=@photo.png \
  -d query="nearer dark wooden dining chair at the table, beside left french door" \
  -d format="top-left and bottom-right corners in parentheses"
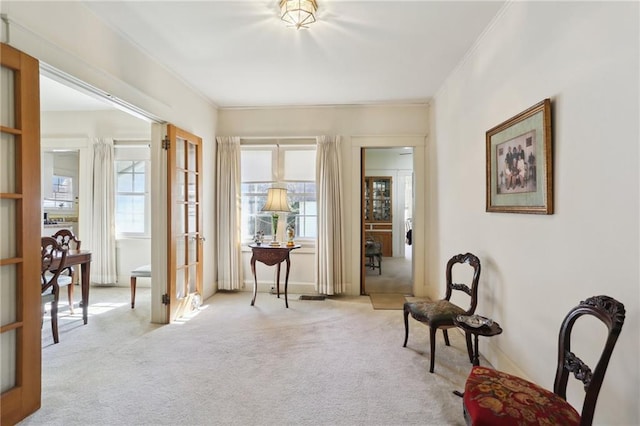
top-left (40, 237), bottom-right (72, 343)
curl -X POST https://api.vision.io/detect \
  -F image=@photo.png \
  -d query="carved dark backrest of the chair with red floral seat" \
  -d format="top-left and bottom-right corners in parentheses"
top-left (553, 296), bottom-right (625, 425)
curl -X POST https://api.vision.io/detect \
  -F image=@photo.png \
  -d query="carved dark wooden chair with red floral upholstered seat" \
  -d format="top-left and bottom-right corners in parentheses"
top-left (463, 296), bottom-right (625, 426)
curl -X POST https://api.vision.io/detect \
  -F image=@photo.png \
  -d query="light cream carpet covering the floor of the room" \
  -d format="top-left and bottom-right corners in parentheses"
top-left (21, 287), bottom-right (476, 426)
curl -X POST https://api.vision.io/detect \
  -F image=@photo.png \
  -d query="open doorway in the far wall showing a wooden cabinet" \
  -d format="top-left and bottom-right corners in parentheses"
top-left (360, 148), bottom-right (414, 295)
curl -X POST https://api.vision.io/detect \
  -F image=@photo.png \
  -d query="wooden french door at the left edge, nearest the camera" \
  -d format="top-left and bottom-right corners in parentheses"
top-left (0, 43), bottom-right (42, 425)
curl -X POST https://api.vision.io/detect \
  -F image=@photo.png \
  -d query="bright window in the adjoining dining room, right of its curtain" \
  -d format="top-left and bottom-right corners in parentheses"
top-left (114, 145), bottom-right (151, 236)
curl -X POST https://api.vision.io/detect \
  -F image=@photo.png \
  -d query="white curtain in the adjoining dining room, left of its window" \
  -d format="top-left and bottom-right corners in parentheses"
top-left (91, 138), bottom-right (117, 285)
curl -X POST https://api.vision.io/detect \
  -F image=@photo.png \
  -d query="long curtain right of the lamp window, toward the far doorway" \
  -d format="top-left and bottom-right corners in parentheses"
top-left (316, 136), bottom-right (345, 295)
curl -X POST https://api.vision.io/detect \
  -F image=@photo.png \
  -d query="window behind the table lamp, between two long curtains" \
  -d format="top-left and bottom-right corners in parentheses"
top-left (240, 144), bottom-right (318, 240)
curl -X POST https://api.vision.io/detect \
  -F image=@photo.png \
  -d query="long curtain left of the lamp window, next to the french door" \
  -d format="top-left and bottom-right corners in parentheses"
top-left (216, 136), bottom-right (244, 290)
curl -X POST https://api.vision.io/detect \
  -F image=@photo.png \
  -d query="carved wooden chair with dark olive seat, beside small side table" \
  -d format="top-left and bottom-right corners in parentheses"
top-left (402, 253), bottom-right (480, 373)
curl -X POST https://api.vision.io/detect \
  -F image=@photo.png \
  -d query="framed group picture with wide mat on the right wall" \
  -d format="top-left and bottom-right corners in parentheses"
top-left (486, 99), bottom-right (553, 214)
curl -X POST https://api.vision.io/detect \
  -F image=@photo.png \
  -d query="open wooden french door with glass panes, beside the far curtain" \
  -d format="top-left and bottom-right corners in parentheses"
top-left (165, 125), bottom-right (204, 321)
